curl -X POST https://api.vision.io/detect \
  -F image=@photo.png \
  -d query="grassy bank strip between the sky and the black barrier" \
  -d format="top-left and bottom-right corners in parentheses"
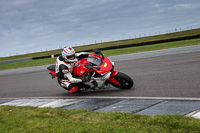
top-left (0, 28), bottom-right (200, 61)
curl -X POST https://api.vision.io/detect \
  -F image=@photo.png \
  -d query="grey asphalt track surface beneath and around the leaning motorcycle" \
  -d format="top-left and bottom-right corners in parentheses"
top-left (0, 45), bottom-right (200, 98)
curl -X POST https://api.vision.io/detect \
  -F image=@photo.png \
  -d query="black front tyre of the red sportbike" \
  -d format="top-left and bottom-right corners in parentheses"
top-left (113, 72), bottom-right (134, 89)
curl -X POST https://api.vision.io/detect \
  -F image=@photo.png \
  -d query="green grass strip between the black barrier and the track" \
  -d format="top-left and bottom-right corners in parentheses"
top-left (0, 39), bottom-right (200, 70)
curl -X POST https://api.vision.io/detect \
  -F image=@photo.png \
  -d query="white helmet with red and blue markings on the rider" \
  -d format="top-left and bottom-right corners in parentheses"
top-left (62, 47), bottom-right (76, 63)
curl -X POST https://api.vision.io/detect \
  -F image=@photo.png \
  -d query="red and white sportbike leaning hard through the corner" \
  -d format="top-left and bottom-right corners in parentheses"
top-left (47, 49), bottom-right (134, 91)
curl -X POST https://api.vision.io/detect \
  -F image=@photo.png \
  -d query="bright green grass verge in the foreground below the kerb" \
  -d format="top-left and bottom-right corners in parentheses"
top-left (0, 106), bottom-right (200, 133)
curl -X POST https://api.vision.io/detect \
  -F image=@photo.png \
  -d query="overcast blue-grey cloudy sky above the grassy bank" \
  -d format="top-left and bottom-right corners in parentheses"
top-left (0, 0), bottom-right (200, 57)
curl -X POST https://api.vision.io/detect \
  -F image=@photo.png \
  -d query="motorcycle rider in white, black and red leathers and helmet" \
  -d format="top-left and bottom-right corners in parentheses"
top-left (56, 47), bottom-right (90, 93)
